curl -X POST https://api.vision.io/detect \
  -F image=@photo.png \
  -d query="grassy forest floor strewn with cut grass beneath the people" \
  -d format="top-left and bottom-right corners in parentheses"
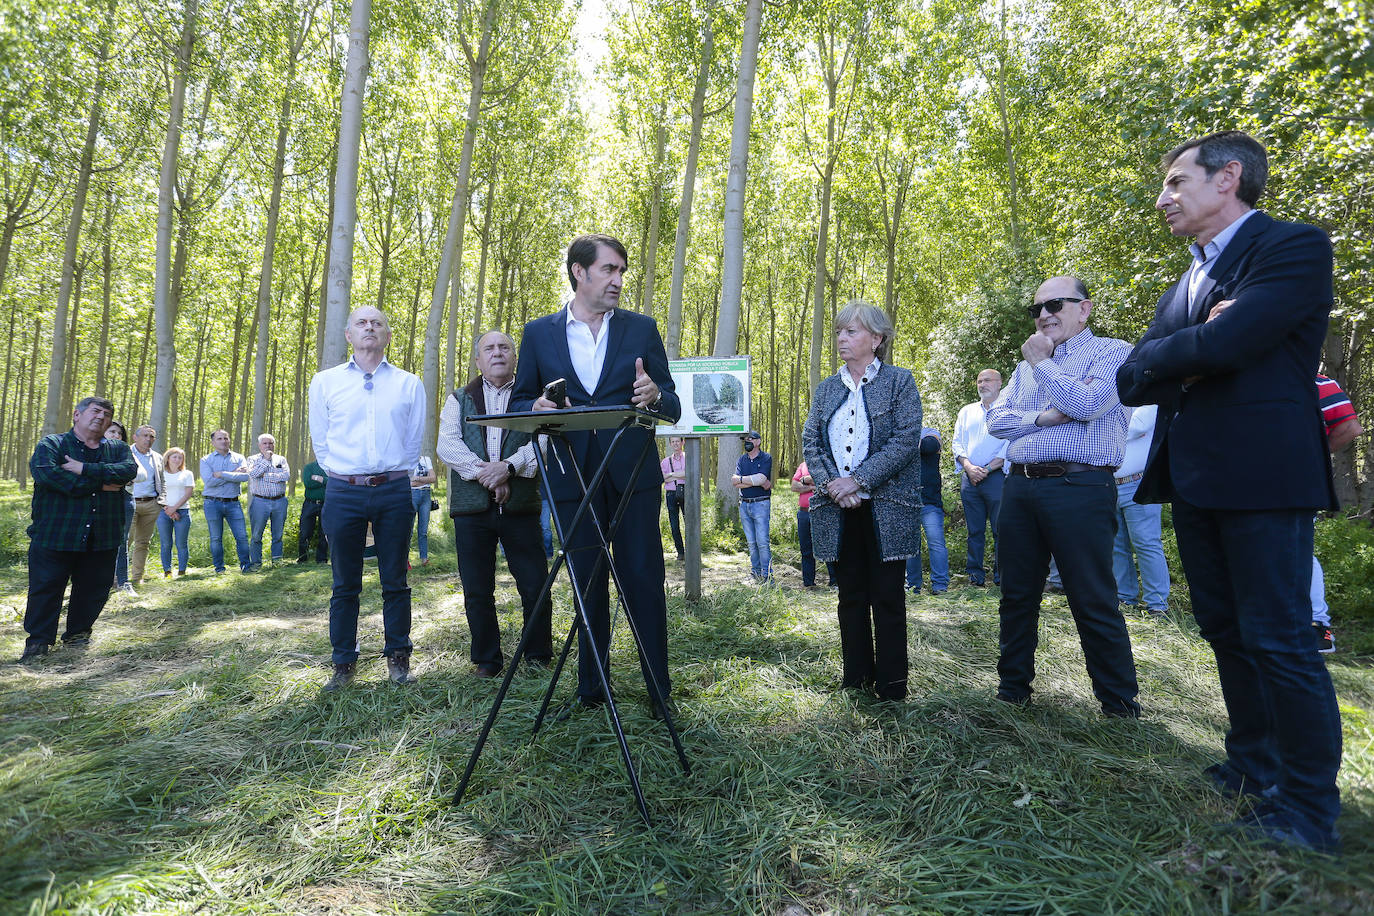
top-left (0, 541), bottom-right (1374, 916)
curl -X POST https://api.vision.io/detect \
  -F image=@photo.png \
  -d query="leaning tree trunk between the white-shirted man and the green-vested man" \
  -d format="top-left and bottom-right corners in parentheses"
top-left (420, 0), bottom-right (500, 455)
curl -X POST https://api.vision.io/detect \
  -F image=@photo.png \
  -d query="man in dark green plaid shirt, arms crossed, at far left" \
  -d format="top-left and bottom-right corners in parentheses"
top-left (19, 397), bottom-right (139, 662)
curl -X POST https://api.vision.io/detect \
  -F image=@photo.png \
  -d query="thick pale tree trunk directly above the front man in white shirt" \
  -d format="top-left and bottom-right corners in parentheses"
top-left (319, 0), bottom-right (372, 369)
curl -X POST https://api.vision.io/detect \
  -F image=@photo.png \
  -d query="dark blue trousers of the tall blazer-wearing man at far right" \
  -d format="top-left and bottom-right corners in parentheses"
top-left (1173, 500), bottom-right (1341, 834)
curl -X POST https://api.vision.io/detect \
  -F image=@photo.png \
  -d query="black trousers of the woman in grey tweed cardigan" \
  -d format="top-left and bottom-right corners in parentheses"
top-left (834, 500), bottom-right (907, 700)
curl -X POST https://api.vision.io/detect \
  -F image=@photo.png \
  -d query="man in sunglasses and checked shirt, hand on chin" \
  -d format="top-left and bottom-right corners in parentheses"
top-left (988, 276), bottom-right (1140, 718)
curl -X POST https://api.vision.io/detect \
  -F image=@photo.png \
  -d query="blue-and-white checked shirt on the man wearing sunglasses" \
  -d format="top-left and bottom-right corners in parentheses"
top-left (988, 328), bottom-right (1131, 467)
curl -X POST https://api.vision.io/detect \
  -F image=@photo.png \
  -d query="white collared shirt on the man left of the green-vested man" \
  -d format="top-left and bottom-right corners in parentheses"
top-left (311, 357), bottom-right (429, 475)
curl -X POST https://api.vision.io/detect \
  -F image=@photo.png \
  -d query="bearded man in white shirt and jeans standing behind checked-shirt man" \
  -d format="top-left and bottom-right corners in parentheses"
top-left (954, 369), bottom-right (1007, 586)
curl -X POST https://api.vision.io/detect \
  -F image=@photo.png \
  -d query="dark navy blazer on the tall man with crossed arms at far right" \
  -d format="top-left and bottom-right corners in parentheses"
top-left (1117, 213), bottom-right (1336, 509)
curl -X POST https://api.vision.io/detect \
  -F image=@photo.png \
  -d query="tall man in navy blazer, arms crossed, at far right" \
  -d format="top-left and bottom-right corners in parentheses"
top-left (1117, 130), bottom-right (1341, 851)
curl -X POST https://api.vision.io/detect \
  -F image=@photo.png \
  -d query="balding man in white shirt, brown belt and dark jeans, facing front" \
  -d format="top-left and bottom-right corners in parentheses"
top-left (311, 306), bottom-right (427, 691)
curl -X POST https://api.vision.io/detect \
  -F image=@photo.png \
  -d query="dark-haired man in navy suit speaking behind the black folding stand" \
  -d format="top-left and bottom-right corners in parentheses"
top-left (510, 235), bottom-right (682, 715)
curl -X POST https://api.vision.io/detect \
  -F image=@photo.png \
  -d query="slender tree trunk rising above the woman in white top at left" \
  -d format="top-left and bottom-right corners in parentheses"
top-left (148, 0), bottom-right (198, 430)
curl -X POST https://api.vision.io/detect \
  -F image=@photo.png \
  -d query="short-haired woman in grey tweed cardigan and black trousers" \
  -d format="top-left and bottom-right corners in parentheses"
top-left (801, 299), bottom-right (921, 700)
